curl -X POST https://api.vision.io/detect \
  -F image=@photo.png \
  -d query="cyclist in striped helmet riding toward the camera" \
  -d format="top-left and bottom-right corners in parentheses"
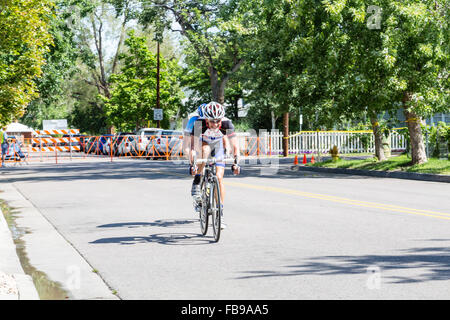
top-left (191, 101), bottom-right (240, 228)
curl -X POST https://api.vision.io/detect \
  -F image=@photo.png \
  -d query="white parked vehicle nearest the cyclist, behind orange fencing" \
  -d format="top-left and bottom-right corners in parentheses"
top-left (146, 130), bottom-right (183, 159)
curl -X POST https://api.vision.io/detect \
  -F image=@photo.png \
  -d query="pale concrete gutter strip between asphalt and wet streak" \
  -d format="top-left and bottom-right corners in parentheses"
top-left (0, 183), bottom-right (120, 300)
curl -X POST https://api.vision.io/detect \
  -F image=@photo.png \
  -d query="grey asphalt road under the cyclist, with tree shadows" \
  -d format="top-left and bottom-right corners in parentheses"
top-left (0, 160), bottom-right (450, 300)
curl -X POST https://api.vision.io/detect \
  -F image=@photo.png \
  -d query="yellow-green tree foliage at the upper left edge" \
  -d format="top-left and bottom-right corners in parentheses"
top-left (0, 0), bottom-right (54, 124)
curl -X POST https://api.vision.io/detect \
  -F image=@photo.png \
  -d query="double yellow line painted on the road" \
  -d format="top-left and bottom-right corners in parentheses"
top-left (225, 181), bottom-right (450, 220)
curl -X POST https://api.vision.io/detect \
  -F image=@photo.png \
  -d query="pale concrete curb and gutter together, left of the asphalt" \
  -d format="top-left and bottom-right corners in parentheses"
top-left (0, 183), bottom-right (118, 300)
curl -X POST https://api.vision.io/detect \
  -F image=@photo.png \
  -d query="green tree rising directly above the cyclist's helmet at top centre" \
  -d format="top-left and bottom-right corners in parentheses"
top-left (140, 0), bottom-right (254, 103)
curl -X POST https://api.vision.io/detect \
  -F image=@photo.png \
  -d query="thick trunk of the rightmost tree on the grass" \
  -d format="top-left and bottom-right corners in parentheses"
top-left (403, 93), bottom-right (428, 165)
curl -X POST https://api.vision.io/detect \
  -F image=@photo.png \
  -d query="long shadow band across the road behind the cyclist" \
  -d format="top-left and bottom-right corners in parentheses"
top-left (2, 160), bottom-right (373, 183)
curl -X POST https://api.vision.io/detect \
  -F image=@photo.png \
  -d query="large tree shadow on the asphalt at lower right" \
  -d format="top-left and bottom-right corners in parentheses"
top-left (236, 239), bottom-right (450, 284)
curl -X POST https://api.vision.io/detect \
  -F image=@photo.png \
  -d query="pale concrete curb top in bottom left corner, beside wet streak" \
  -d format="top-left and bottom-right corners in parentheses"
top-left (0, 208), bottom-right (40, 300)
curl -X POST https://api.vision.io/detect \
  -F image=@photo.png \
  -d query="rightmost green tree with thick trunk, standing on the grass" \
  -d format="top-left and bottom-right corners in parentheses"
top-left (385, 0), bottom-right (450, 164)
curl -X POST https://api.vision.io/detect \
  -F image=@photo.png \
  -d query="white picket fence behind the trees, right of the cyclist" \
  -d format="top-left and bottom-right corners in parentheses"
top-left (238, 131), bottom-right (406, 155)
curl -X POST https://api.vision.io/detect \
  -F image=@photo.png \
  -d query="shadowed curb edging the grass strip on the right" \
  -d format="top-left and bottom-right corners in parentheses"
top-left (290, 165), bottom-right (450, 183)
